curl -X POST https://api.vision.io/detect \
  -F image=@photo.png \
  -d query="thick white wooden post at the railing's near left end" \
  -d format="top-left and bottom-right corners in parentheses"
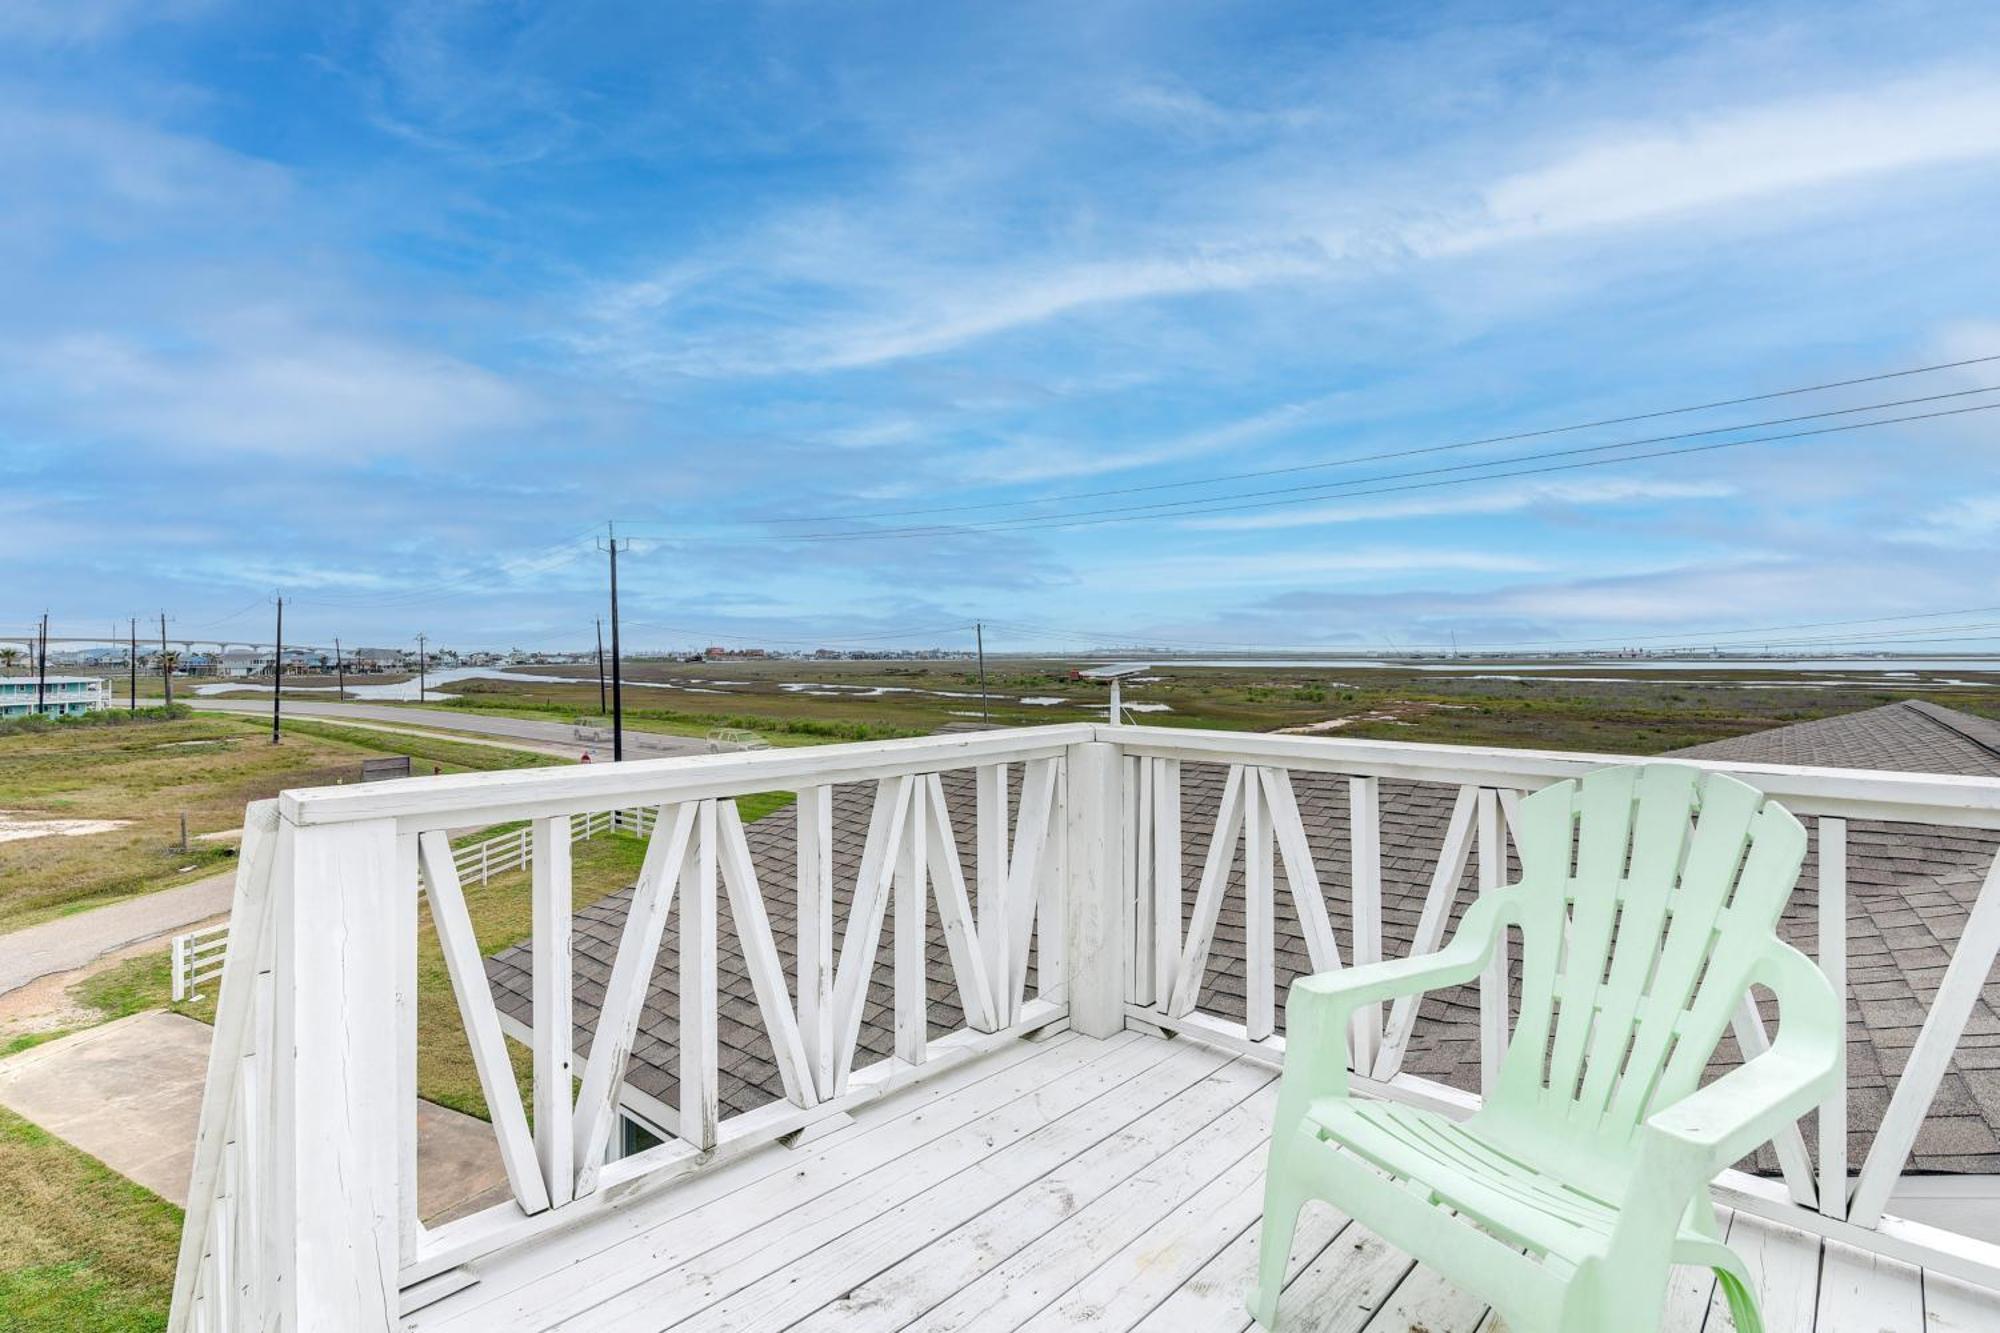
top-left (268, 819), bottom-right (406, 1333)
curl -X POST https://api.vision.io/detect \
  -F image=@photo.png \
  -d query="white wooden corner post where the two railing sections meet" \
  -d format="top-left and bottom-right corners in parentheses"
top-left (1048, 741), bottom-right (1130, 1037)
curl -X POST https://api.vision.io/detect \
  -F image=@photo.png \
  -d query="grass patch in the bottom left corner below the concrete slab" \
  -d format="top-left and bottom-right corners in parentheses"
top-left (0, 1109), bottom-right (180, 1333)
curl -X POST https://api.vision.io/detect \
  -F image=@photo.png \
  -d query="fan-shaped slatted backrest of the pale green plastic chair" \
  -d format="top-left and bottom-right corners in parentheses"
top-left (1494, 765), bottom-right (1806, 1139)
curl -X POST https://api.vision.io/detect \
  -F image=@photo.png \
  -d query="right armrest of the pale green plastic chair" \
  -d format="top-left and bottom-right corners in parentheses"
top-left (1644, 945), bottom-right (1848, 1179)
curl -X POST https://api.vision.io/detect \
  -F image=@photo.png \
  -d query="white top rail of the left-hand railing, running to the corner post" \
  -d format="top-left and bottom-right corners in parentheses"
top-left (278, 723), bottom-right (1100, 833)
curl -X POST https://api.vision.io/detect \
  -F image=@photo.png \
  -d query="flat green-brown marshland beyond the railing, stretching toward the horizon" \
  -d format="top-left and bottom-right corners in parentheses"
top-left (274, 658), bottom-right (2000, 753)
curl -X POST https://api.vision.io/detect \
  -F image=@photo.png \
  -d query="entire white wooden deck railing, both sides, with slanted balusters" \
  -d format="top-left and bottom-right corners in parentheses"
top-left (170, 725), bottom-right (2000, 1331)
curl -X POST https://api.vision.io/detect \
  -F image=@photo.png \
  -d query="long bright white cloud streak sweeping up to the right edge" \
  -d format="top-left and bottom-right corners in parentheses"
top-left (574, 70), bottom-right (2000, 376)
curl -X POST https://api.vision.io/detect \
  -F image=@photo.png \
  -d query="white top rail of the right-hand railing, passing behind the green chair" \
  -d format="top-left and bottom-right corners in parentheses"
top-left (1098, 727), bottom-right (2000, 829)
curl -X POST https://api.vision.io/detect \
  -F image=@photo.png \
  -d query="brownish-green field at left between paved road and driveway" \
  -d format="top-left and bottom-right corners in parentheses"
top-left (0, 715), bottom-right (558, 931)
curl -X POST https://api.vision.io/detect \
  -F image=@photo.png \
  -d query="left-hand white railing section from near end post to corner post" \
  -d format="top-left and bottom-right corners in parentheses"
top-left (170, 727), bottom-right (1124, 1329)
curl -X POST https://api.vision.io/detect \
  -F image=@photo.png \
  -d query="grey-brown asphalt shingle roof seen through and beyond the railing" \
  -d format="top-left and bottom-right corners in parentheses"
top-left (488, 701), bottom-right (2000, 1173)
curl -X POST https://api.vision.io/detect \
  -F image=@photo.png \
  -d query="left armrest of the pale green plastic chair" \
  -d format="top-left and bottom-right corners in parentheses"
top-left (1280, 895), bottom-right (1504, 1096)
